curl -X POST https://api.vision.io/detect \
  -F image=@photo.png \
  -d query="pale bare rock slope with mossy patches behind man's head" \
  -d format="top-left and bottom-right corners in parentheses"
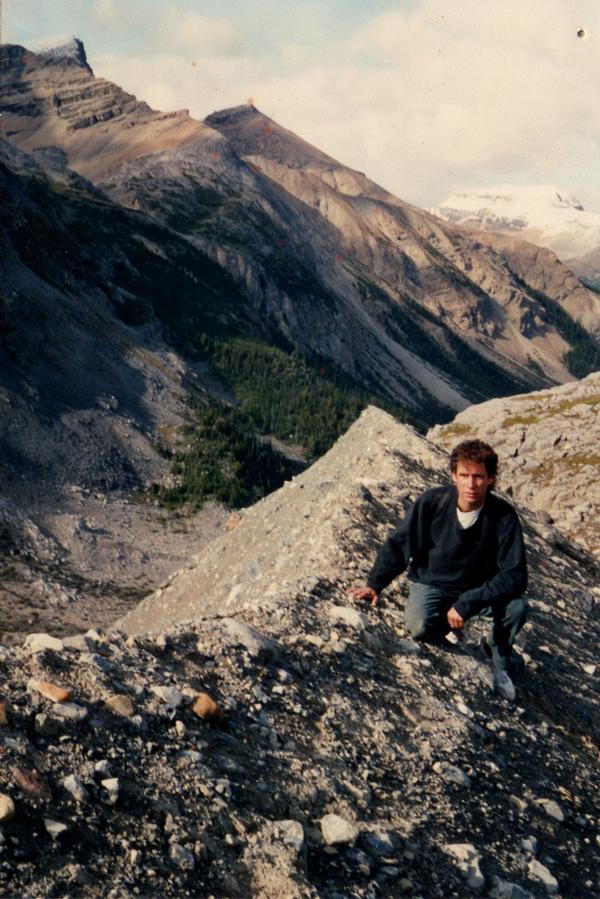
top-left (427, 372), bottom-right (600, 559)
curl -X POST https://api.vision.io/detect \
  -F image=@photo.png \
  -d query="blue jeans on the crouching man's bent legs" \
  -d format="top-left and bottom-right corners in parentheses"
top-left (404, 583), bottom-right (527, 671)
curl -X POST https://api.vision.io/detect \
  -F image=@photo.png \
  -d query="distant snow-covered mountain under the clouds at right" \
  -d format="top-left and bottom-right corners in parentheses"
top-left (431, 185), bottom-right (600, 284)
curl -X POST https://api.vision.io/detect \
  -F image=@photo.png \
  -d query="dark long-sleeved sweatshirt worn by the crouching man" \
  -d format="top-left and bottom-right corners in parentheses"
top-left (367, 484), bottom-right (527, 619)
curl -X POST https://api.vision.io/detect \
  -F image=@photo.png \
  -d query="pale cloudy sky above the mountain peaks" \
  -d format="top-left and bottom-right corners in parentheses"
top-left (0, 0), bottom-right (600, 211)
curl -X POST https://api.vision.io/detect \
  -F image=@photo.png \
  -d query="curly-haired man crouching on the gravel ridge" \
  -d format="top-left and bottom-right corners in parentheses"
top-left (349, 440), bottom-right (527, 700)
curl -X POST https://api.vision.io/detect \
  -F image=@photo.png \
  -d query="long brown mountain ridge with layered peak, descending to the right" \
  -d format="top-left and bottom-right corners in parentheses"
top-left (2, 37), bottom-right (600, 419)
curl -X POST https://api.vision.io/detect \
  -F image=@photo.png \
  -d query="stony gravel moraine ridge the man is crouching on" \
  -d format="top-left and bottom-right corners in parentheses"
top-left (0, 408), bottom-right (600, 899)
